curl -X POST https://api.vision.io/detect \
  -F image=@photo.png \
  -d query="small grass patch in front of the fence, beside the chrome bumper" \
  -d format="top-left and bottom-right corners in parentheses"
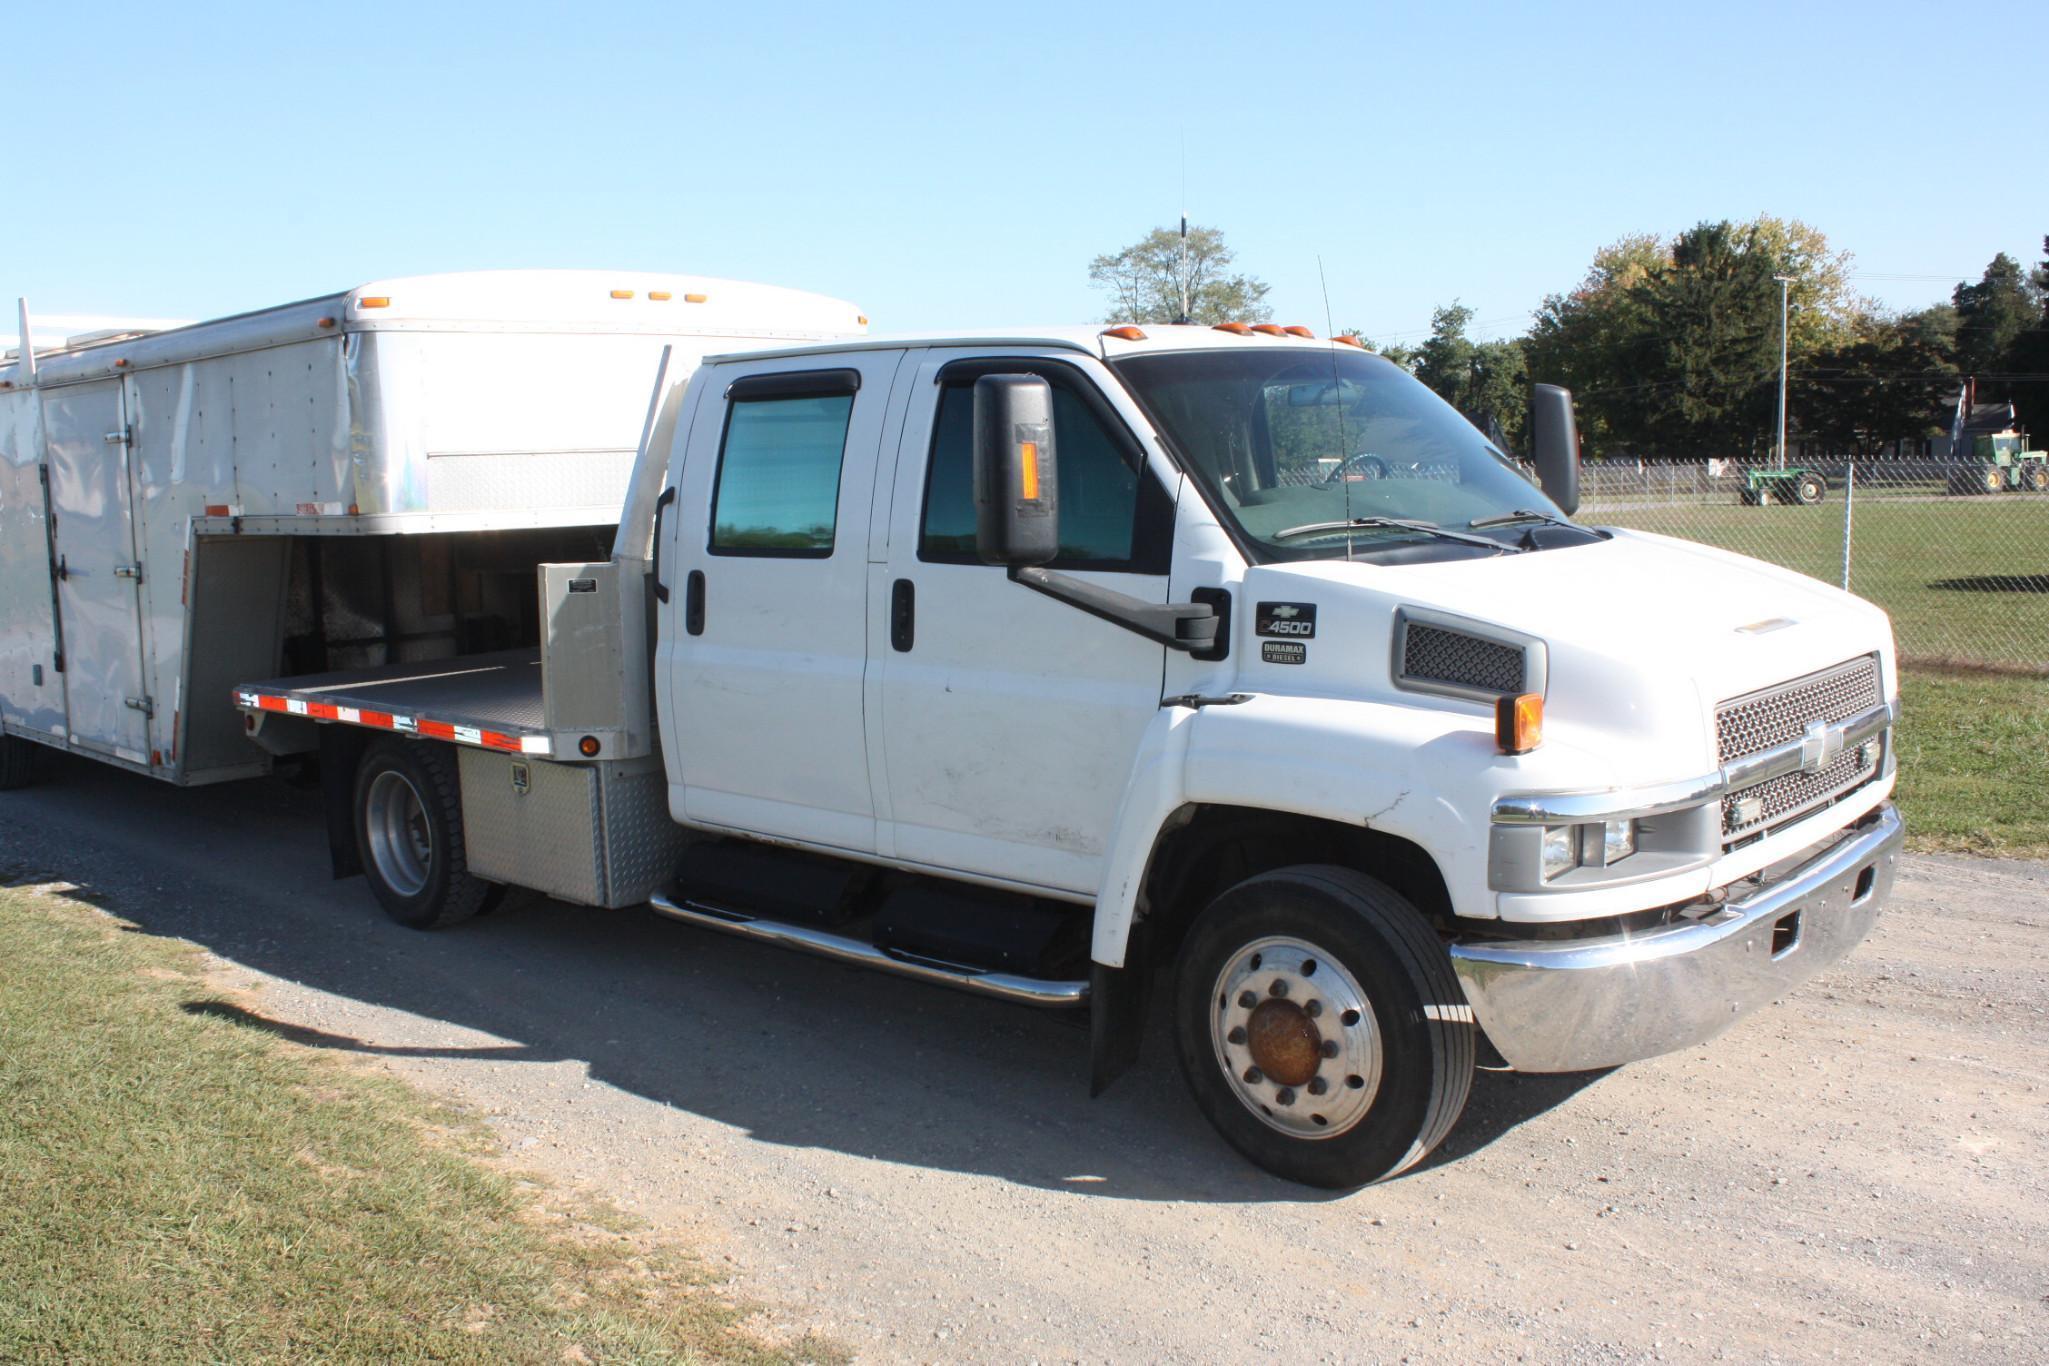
top-left (1897, 670), bottom-right (2049, 858)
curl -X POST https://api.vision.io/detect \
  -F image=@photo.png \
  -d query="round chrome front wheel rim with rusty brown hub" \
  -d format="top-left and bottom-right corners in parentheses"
top-left (1209, 936), bottom-right (1381, 1139)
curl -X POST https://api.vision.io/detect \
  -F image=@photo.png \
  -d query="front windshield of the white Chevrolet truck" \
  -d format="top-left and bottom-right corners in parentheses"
top-left (1113, 346), bottom-right (1563, 559)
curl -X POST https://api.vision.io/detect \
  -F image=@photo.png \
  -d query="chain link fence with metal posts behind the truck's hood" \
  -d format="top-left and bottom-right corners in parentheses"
top-left (1576, 457), bottom-right (2049, 676)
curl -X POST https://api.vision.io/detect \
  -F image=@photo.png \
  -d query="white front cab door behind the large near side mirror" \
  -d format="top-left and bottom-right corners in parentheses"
top-left (879, 350), bottom-right (1172, 895)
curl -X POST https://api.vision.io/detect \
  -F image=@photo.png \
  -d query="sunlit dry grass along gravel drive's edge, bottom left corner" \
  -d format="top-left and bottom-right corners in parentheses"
top-left (0, 889), bottom-right (830, 1362)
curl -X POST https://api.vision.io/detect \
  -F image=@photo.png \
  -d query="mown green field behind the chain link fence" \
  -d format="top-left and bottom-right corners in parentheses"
top-left (1580, 499), bottom-right (2049, 672)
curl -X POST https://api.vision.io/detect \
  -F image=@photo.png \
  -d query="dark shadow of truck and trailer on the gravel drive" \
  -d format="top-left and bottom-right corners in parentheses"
top-left (12, 762), bottom-right (1602, 1202)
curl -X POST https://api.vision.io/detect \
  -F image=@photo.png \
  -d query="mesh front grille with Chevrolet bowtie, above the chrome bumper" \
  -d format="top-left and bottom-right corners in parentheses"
top-left (1715, 655), bottom-right (1885, 840)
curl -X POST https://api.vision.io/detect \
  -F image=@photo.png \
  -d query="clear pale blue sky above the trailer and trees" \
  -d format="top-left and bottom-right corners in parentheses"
top-left (0, 0), bottom-right (2049, 340)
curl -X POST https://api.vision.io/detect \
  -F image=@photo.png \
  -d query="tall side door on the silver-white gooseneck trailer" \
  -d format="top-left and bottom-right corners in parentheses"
top-left (41, 379), bottom-right (152, 764)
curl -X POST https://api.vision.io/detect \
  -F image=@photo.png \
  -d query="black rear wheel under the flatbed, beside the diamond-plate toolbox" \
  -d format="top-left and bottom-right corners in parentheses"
top-left (354, 739), bottom-right (491, 930)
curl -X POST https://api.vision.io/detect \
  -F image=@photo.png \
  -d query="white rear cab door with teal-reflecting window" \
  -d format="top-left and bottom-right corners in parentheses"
top-left (658, 350), bottom-right (904, 854)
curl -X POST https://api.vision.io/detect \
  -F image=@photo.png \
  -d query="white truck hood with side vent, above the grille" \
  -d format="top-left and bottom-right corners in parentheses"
top-left (1240, 530), bottom-right (1897, 780)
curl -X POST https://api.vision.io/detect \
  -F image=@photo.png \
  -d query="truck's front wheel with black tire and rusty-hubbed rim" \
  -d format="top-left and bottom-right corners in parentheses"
top-left (1174, 864), bottom-right (1475, 1190)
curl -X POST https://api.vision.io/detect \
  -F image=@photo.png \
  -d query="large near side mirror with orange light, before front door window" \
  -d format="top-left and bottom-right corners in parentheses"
top-left (975, 375), bottom-right (1059, 569)
